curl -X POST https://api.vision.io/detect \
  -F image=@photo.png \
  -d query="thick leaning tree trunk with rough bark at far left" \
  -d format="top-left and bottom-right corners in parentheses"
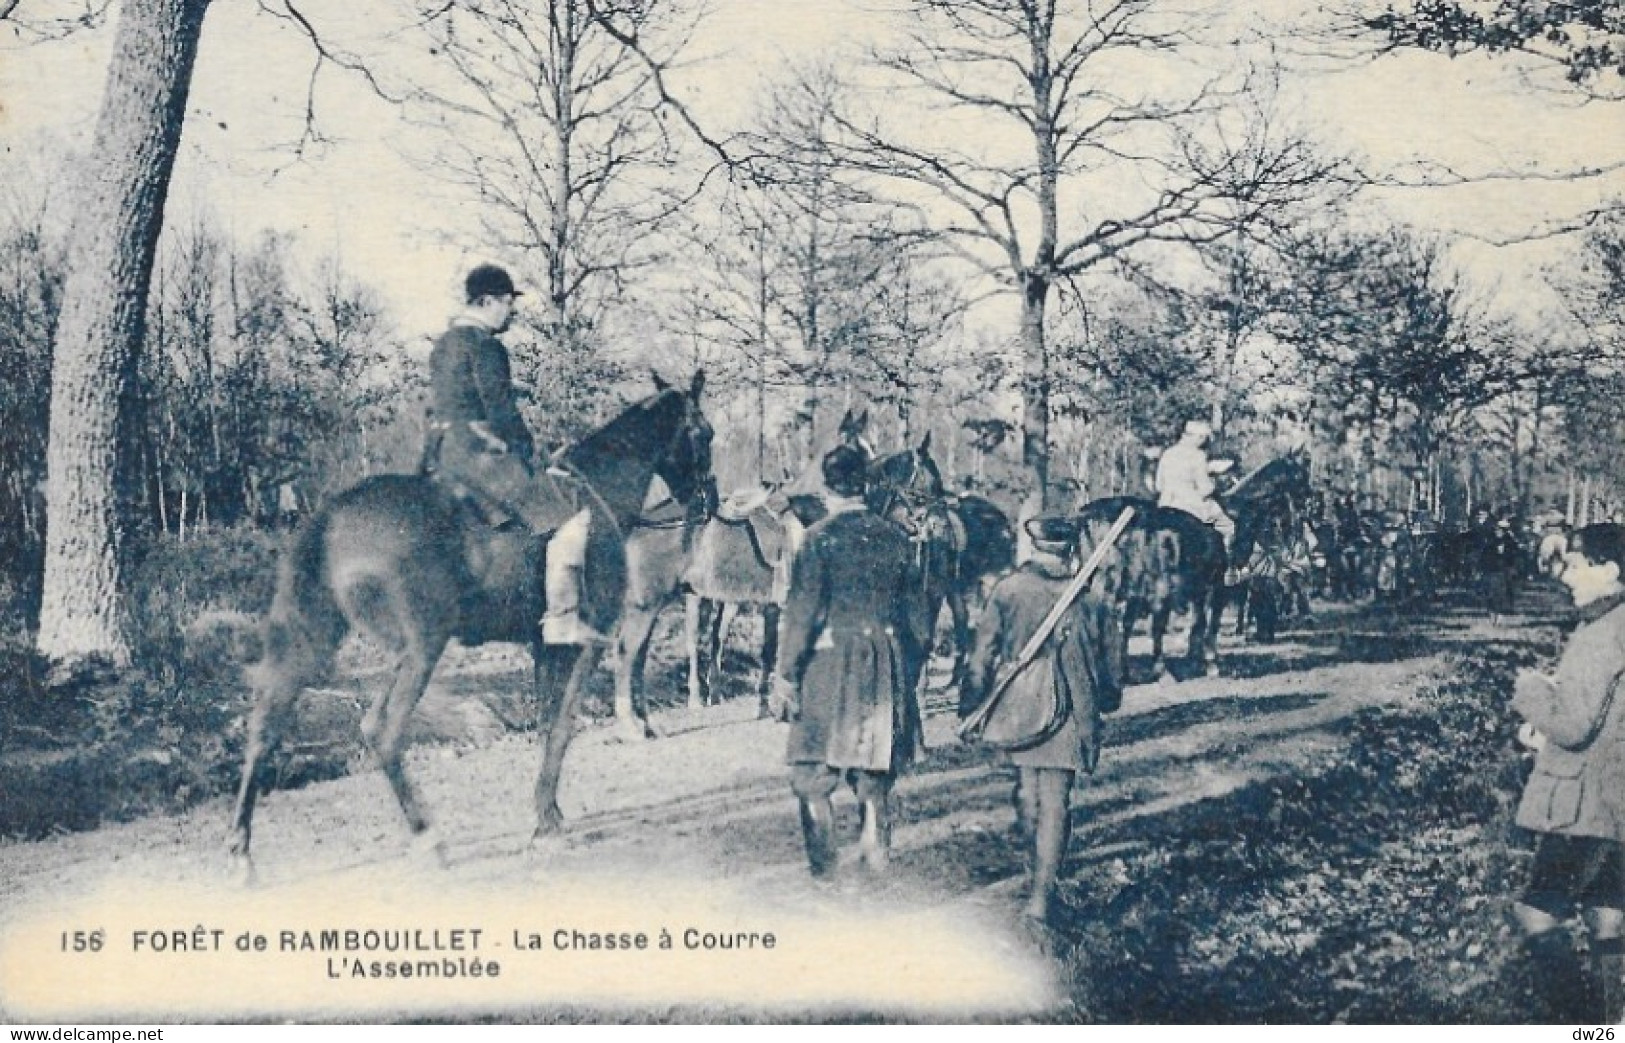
top-left (39, 0), bottom-right (208, 664)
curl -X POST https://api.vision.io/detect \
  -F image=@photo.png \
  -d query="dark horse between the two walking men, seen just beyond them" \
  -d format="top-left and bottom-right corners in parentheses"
top-left (868, 435), bottom-right (1016, 686)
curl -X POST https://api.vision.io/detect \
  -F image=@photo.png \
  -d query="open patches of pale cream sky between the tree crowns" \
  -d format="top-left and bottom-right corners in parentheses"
top-left (0, 0), bottom-right (1625, 335)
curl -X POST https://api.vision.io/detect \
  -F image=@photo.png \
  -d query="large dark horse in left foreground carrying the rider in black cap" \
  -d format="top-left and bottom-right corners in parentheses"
top-left (231, 374), bottom-right (712, 876)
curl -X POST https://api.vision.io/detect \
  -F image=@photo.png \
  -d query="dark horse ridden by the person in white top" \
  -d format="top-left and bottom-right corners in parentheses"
top-left (1079, 452), bottom-right (1310, 676)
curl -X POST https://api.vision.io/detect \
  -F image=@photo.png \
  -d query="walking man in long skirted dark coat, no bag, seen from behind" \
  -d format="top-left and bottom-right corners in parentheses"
top-left (772, 445), bottom-right (930, 877)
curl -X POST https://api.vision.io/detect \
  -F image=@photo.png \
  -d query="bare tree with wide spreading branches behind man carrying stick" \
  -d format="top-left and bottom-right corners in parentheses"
top-left (848, 0), bottom-right (1334, 491)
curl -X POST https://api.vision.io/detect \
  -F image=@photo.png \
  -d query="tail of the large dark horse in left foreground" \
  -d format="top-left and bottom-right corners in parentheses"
top-left (249, 510), bottom-right (346, 690)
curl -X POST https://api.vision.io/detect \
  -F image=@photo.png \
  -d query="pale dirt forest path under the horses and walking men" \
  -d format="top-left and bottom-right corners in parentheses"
top-left (0, 588), bottom-right (1553, 1017)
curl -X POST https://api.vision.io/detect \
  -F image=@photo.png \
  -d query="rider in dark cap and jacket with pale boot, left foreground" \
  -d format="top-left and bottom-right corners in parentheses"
top-left (429, 265), bottom-right (606, 645)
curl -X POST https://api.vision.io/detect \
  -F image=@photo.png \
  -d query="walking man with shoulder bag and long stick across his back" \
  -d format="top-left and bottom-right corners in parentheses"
top-left (960, 515), bottom-right (1123, 923)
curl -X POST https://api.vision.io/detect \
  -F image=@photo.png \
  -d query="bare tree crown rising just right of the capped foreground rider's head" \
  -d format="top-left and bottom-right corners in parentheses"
top-left (414, 0), bottom-right (692, 336)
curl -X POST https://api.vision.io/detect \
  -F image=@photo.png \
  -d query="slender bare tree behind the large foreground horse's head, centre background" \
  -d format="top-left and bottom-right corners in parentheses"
top-left (686, 65), bottom-right (921, 480)
